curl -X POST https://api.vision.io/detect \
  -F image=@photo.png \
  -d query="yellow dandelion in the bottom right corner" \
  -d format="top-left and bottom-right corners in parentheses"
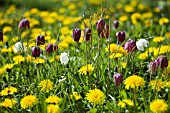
top-left (150, 99), bottom-right (168, 113)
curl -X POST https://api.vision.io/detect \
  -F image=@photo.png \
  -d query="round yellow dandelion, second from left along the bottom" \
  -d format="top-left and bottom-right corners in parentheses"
top-left (20, 95), bottom-right (37, 109)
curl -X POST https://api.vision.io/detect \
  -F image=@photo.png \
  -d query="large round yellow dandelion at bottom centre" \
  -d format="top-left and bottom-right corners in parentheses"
top-left (86, 89), bottom-right (105, 104)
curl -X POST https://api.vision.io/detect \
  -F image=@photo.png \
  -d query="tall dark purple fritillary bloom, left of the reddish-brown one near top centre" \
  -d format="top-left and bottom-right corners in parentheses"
top-left (96, 19), bottom-right (105, 36)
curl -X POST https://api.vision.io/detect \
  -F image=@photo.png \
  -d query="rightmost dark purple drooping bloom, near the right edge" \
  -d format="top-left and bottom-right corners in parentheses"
top-left (155, 56), bottom-right (168, 69)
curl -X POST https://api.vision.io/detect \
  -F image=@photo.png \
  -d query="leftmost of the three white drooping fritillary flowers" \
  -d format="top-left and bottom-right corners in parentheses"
top-left (14, 42), bottom-right (26, 53)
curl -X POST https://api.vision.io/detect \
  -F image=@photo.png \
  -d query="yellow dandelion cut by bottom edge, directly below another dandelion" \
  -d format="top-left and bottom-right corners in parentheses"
top-left (47, 104), bottom-right (61, 113)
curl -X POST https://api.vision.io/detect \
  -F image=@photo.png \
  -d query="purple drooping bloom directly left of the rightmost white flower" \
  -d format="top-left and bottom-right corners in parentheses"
top-left (124, 39), bottom-right (136, 52)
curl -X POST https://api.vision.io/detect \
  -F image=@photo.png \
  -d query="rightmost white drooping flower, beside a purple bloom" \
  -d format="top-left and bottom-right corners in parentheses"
top-left (136, 39), bottom-right (149, 51)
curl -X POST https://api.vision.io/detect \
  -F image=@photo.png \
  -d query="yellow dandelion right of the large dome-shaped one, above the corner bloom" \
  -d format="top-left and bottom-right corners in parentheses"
top-left (149, 79), bottom-right (166, 91)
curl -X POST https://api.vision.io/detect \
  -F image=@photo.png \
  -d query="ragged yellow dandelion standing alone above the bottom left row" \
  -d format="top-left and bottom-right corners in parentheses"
top-left (39, 79), bottom-right (53, 93)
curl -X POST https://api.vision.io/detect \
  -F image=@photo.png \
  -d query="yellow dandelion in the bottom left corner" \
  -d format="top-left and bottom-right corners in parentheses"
top-left (0, 98), bottom-right (17, 108)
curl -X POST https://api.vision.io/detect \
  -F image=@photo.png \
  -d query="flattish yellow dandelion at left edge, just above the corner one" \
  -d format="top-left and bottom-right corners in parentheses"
top-left (0, 86), bottom-right (17, 96)
